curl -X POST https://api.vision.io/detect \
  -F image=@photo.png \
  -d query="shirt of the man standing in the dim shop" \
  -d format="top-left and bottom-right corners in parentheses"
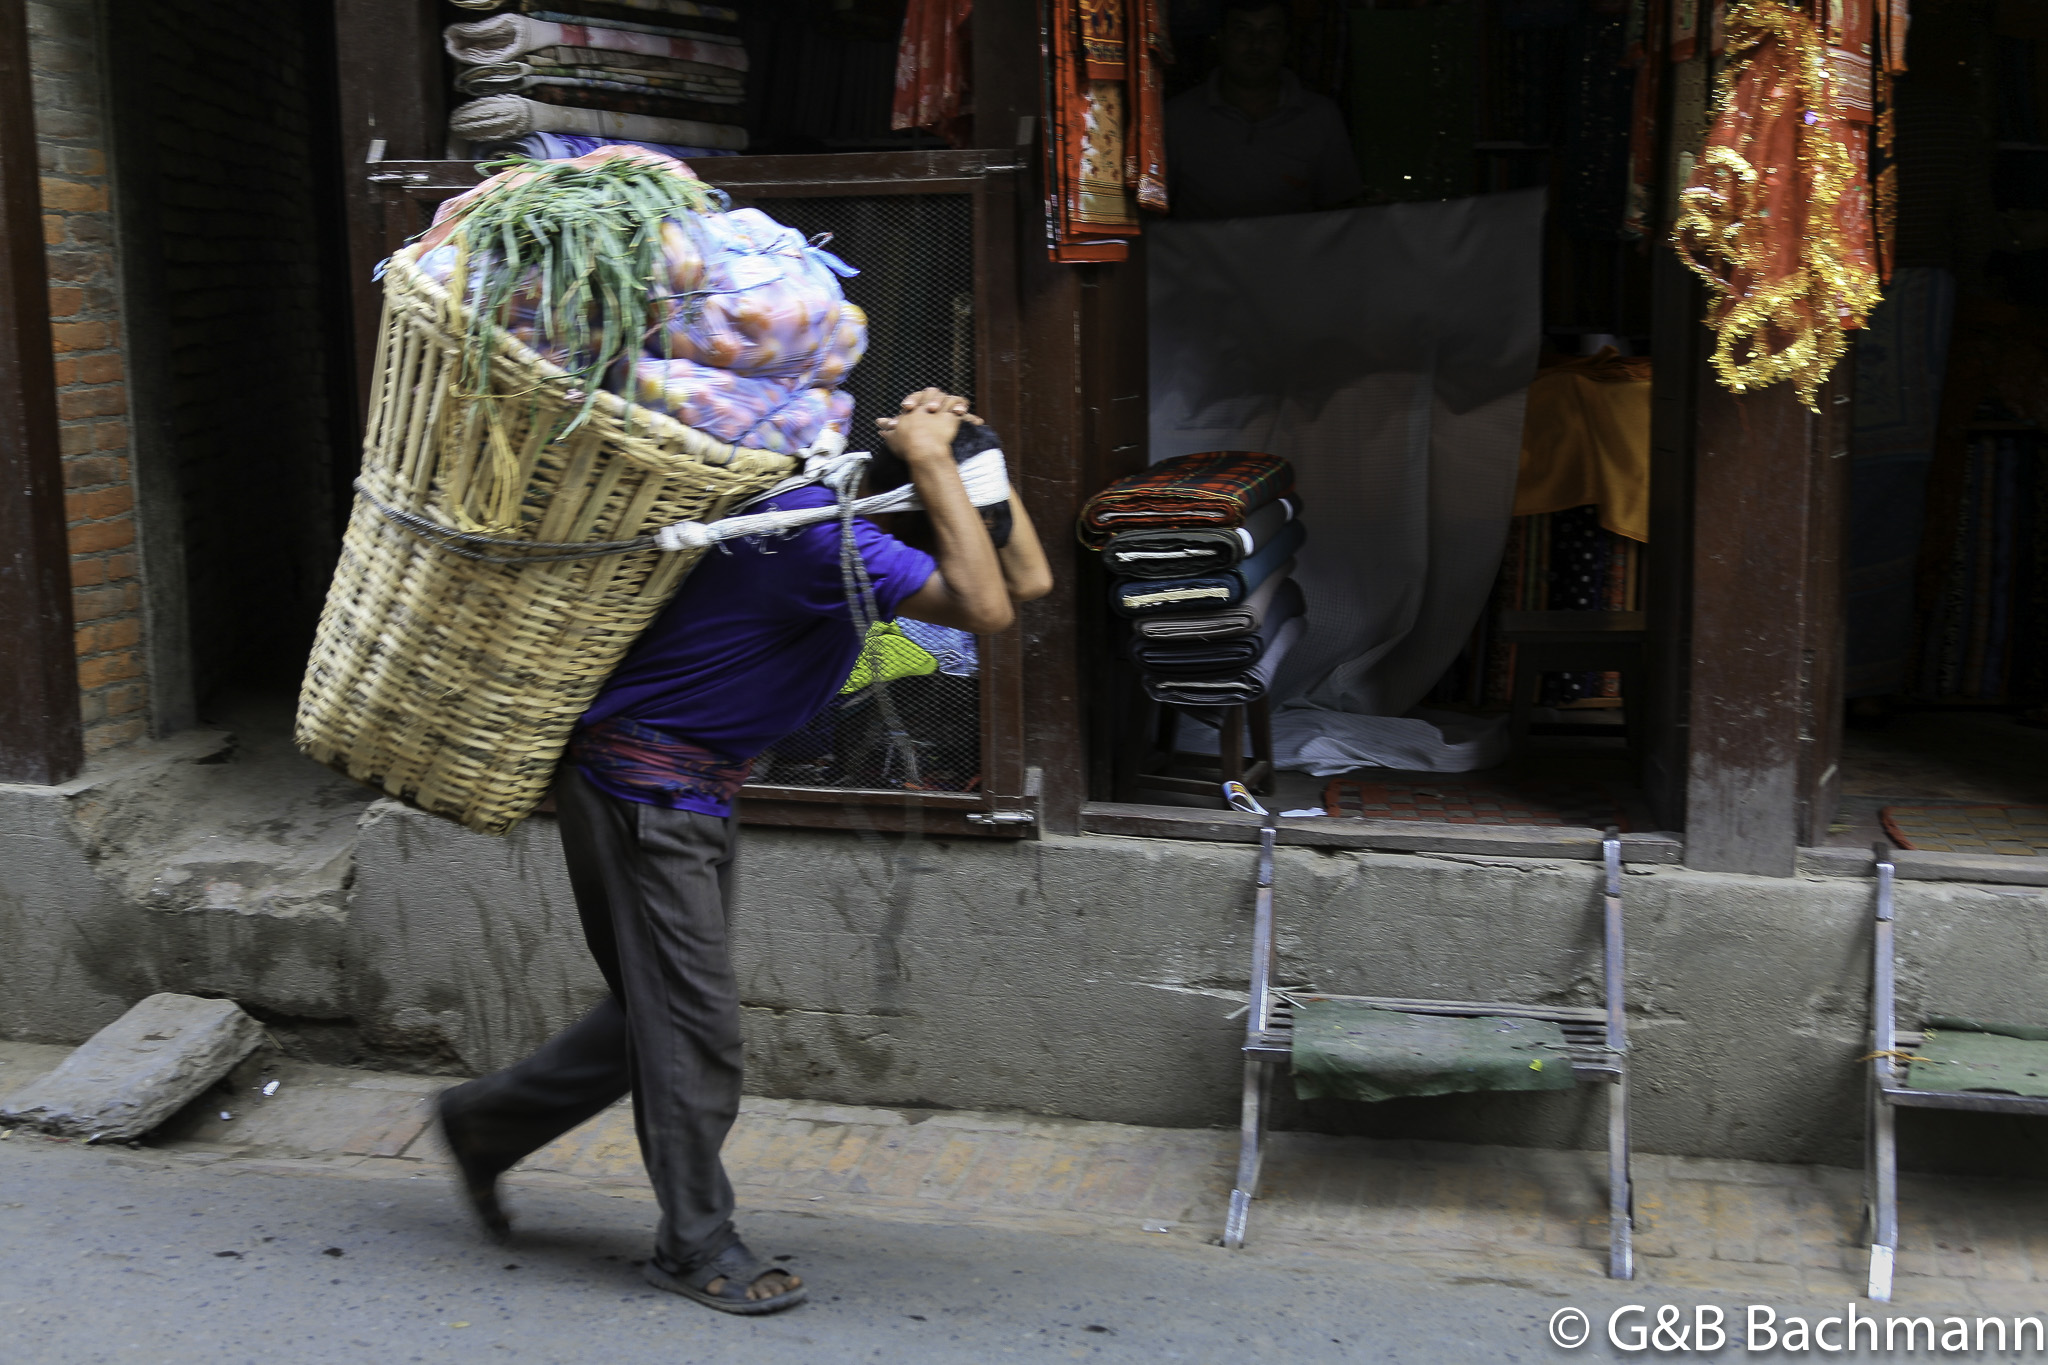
top-left (1165, 72), bottom-right (1364, 219)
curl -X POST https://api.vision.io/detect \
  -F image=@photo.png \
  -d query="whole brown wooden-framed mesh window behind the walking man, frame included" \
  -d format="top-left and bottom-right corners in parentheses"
top-left (352, 149), bottom-right (1040, 835)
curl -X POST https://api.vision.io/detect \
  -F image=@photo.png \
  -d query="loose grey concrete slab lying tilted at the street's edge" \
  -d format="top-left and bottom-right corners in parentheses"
top-left (0, 993), bottom-right (262, 1142)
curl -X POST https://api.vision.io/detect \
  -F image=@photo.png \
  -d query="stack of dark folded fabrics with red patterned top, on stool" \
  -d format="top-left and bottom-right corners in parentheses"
top-left (1081, 450), bottom-right (1309, 706)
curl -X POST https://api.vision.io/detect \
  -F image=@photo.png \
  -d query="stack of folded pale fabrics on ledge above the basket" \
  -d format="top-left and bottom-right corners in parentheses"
top-left (444, 0), bottom-right (748, 158)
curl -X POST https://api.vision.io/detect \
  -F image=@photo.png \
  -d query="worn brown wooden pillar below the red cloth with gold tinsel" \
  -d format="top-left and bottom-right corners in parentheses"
top-left (1686, 377), bottom-right (1847, 876)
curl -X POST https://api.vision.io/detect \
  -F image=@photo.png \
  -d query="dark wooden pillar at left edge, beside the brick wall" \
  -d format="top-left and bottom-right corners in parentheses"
top-left (0, 0), bottom-right (84, 782)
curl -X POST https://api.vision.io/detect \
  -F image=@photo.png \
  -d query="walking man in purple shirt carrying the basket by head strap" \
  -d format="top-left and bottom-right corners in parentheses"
top-left (425, 389), bottom-right (1053, 1314)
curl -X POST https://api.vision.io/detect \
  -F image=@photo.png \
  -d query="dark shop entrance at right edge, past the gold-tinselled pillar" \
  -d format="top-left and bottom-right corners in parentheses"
top-left (1827, 4), bottom-right (2048, 855)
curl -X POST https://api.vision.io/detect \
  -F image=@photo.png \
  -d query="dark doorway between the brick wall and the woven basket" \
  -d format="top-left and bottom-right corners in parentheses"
top-left (106, 0), bottom-right (354, 733)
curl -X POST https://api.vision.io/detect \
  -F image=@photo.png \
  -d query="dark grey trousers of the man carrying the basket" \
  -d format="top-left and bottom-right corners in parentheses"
top-left (444, 763), bottom-right (741, 1271)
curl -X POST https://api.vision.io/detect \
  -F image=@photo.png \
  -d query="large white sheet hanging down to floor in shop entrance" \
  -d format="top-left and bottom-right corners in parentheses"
top-left (1147, 190), bottom-right (1542, 772)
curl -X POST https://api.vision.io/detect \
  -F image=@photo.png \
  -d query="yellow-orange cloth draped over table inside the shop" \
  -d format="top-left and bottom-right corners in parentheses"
top-left (1516, 348), bottom-right (1651, 542)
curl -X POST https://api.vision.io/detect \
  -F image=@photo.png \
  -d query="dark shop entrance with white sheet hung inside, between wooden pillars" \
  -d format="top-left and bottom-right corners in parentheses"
top-left (1106, 0), bottom-right (1671, 831)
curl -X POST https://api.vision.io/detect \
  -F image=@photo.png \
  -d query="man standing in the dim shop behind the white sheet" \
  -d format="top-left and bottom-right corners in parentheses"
top-left (1165, 0), bottom-right (1362, 219)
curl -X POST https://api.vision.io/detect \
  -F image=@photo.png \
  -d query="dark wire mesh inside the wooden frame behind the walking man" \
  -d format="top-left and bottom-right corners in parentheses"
top-left (754, 194), bottom-right (981, 792)
